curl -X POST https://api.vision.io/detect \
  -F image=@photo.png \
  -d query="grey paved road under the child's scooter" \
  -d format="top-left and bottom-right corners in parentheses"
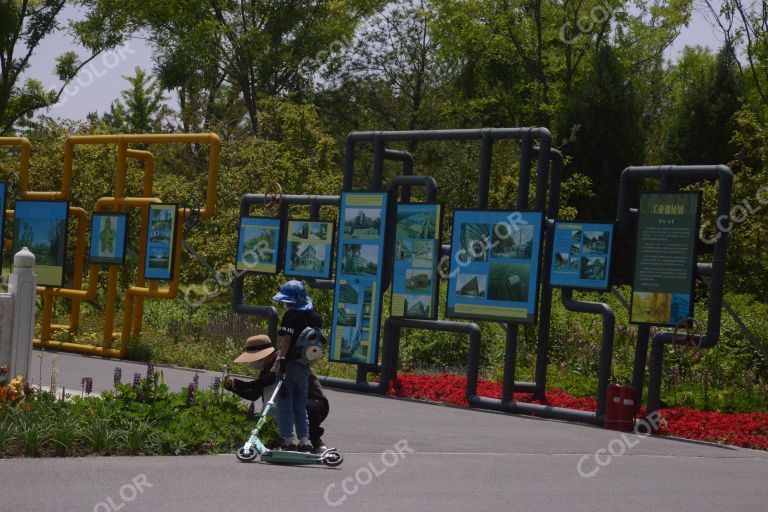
top-left (0, 355), bottom-right (768, 512)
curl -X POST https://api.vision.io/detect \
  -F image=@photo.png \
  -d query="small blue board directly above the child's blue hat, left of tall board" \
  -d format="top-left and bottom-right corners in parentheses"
top-left (283, 220), bottom-right (336, 279)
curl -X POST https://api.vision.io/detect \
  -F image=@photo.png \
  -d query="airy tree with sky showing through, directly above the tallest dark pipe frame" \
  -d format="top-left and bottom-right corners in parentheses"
top-left (320, 0), bottom-right (451, 140)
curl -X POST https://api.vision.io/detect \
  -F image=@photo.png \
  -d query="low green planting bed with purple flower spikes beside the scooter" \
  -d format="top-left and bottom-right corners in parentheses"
top-left (0, 373), bottom-right (279, 457)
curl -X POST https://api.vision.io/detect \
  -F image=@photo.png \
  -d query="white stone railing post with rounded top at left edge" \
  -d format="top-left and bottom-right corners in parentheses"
top-left (0, 247), bottom-right (37, 380)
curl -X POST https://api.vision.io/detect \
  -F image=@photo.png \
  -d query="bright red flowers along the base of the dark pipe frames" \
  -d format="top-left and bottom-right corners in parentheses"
top-left (389, 374), bottom-right (768, 450)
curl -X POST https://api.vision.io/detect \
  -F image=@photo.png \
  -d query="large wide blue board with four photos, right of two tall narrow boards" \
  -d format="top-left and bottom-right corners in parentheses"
top-left (446, 210), bottom-right (544, 324)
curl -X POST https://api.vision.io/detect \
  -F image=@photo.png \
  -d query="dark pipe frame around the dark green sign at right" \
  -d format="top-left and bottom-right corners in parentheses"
top-left (618, 165), bottom-right (733, 424)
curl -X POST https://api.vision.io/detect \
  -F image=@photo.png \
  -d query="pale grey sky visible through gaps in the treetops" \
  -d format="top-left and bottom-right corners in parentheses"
top-left (19, 2), bottom-right (722, 119)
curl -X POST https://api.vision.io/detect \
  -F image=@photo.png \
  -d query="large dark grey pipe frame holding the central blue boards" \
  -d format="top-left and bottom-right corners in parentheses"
top-left (235, 128), bottom-right (613, 424)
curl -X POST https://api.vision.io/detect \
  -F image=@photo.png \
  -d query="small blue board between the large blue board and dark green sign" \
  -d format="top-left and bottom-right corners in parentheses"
top-left (549, 221), bottom-right (615, 290)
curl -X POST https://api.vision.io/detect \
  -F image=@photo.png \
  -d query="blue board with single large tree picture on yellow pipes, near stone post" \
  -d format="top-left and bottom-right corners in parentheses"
top-left (13, 199), bottom-right (69, 288)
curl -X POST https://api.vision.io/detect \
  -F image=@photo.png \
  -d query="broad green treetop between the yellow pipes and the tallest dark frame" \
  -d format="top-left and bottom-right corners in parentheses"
top-left (100, 0), bottom-right (383, 135)
